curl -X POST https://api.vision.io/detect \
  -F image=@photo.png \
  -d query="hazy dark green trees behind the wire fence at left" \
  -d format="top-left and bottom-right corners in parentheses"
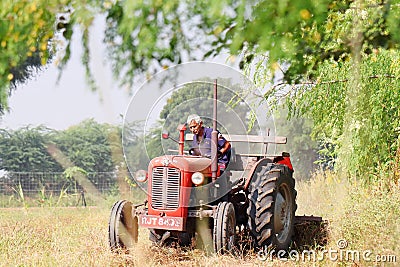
top-left (0, 119), bottom-right (124, 172)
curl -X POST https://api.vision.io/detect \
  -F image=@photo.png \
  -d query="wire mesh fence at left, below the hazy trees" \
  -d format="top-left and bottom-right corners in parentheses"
top-left (0, 172), bottom-right (135, 208)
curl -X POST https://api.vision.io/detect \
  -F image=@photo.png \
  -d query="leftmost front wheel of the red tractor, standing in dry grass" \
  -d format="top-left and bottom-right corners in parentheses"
top-left (108, 200), bottom-right (139, 251)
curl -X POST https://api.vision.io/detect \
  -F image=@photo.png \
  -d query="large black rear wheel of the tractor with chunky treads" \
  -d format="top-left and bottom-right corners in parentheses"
top-left (247, 164), bottom-right (297, 250)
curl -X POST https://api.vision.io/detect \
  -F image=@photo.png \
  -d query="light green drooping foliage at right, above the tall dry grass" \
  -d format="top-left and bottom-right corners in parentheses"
top-left (286, 50), bottom-right (400, 180)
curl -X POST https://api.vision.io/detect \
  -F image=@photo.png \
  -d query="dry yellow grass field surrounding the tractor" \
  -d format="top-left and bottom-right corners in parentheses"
top-left (0, 174), bottom-right (400, 266)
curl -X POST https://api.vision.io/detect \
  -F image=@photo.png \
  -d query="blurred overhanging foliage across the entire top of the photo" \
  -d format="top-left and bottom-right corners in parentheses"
top-left (4, 0), bottom-right (400, 105)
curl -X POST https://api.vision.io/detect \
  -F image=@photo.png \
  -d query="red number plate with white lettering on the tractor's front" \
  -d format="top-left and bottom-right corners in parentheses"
top-left (139, 215), bottom-right (183, 231)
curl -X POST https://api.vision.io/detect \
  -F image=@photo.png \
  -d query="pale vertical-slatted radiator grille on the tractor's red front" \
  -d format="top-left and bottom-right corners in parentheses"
top-left (151, 167), bottom-right (181, 210)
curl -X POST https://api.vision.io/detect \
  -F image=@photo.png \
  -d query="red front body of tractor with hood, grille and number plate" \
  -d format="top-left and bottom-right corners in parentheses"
top-left (139, 155), bottom-right (216, 231)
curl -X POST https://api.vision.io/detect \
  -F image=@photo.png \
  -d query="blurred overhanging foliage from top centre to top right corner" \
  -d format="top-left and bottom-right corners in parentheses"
top-left (100, 0), bottom-right (400, 87)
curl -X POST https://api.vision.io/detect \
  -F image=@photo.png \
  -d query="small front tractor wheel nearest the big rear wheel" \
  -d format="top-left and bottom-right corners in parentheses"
top-left (213, 202), bottom-right (236, 254)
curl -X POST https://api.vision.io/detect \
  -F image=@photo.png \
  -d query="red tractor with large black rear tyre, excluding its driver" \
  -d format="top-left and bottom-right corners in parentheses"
top-left (109, 85), bottom-right (297, 253)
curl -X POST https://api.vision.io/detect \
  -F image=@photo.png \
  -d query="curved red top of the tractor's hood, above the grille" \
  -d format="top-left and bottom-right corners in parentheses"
top-left (149, 155), bottom-right (211, 172)
